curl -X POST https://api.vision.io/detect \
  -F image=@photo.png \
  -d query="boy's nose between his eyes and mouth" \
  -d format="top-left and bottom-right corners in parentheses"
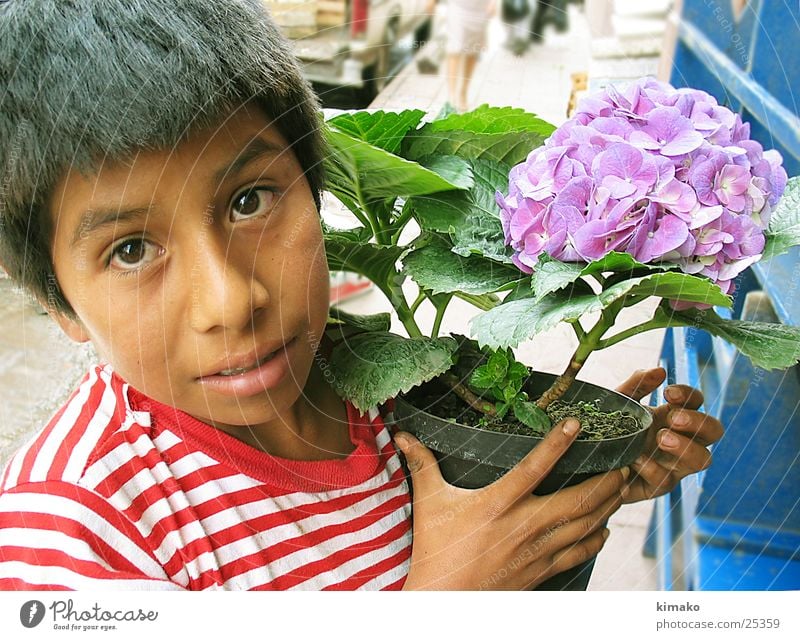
top-left (189, 234), bottom-right (269, 333)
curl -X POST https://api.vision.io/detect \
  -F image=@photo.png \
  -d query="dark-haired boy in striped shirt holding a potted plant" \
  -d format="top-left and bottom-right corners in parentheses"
top-left (0, 0), bottom-right (720, 590)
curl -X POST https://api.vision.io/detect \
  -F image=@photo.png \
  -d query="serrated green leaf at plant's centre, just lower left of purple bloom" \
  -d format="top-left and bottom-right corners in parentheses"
top-left (402, 234), bottom-right (522, 294)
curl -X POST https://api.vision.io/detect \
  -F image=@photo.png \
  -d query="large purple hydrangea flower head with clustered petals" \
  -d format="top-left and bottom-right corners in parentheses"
top-left (497, 78), bottom-right (787, 302)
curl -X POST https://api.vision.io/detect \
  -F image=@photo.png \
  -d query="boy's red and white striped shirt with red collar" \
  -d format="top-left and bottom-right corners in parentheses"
top-left (0, 366), bottom-right (411, 590)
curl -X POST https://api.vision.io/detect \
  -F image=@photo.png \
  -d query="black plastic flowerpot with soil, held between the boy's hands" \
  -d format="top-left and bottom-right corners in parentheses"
top-left (395, 373), bottom-right (652, 590)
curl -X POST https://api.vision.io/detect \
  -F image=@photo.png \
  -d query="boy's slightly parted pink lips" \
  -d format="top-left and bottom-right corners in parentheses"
top-left (198, 337), bottom-right (297, 397)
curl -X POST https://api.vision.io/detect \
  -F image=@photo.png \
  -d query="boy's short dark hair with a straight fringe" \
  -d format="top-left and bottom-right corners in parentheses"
top-left (0, 0), bottom-right (324, 314)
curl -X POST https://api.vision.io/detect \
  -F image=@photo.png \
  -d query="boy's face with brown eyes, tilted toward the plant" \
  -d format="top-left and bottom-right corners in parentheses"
top-left (49, 107), bottom-right (329, 430)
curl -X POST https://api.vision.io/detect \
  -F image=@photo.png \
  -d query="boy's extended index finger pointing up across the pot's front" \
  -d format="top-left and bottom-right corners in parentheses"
top-left (486, 418), bottom-right (580, 510)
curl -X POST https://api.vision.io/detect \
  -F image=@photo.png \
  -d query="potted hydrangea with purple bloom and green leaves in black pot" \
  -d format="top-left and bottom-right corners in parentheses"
top-left (325, 79), bottom-right (800, 584)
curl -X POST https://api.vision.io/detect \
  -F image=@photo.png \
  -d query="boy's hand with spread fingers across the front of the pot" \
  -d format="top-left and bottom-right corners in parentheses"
top-left (395, 420), bottom-right (629, 590)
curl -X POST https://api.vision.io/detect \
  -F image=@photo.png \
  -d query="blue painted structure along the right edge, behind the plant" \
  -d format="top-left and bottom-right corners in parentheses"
top-left (645, 0), bottom-right (800, 590)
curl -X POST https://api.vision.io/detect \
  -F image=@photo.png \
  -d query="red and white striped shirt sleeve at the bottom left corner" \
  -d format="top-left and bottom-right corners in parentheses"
top-left (0, 480), bottom-right (184, 591)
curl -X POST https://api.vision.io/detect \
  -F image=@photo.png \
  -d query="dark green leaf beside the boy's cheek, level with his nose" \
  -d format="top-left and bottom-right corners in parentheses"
top-left (323, 225), bottom-right (403, 286)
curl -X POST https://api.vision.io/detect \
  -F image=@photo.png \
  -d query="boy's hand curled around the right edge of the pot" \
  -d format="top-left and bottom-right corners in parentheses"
top-left (617, 368), bottom-right (723, 502)
